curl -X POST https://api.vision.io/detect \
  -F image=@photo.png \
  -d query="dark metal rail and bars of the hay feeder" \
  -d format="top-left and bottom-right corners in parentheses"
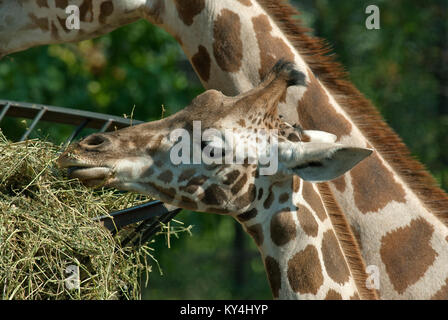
top-left (0, 99), bottom-right (181, 245)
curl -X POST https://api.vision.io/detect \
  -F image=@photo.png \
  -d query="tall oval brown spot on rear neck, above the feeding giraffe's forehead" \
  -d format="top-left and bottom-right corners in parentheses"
top-left (213, 9), bottom-right (243, 72)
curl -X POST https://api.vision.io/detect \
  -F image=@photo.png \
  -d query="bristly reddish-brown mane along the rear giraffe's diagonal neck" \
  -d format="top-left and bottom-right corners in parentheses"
top-left (257, 0), bottom-right (448, 226)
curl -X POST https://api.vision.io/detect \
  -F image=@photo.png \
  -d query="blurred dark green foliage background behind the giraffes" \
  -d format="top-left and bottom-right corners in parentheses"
top-left (0, 0), bottom-right (448, 299)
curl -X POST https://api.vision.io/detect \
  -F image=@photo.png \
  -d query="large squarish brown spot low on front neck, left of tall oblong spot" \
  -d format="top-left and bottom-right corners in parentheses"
top-left (288, 245), bottom-right (324, 294)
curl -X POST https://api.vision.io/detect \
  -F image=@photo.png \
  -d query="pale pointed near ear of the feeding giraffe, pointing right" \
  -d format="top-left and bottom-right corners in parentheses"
top-left (279, 142), bottom-right (373, 182)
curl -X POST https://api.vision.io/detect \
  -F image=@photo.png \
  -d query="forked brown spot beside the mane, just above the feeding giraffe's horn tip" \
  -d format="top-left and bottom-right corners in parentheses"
top-left (252, 14), bottom-right (294, 79)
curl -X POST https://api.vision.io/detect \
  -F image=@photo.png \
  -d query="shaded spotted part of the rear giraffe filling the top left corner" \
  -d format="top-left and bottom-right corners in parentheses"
top-left (0, 0), bottom-right (143, 59)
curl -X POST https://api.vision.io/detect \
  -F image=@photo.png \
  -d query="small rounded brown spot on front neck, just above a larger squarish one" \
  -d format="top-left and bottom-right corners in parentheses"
top-left (270, 210), bottom-right (296, 246)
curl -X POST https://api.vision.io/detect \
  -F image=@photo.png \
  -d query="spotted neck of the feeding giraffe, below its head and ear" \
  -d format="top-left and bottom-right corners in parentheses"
top-left (236, 178), bottom-right (376, 300)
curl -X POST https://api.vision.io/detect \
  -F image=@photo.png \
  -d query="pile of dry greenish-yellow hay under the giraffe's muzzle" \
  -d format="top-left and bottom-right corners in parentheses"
top-left (0, 131), bottom-right (161, 299)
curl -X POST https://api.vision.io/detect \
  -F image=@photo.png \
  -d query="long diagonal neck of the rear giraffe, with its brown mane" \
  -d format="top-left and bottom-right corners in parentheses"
top-left (151, 0), bottom-right (448, 299)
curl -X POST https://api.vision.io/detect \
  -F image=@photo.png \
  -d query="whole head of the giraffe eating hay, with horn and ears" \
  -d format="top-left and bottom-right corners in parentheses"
top-left (58, 61), bottom-right (372, 213)
